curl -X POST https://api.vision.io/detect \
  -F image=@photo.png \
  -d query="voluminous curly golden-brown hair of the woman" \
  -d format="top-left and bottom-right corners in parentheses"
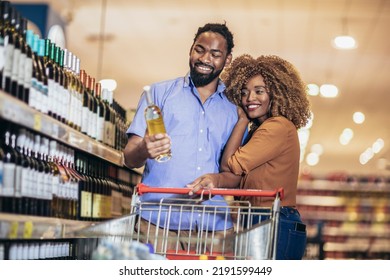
top-left (221, 54), bottom-right (311, 129)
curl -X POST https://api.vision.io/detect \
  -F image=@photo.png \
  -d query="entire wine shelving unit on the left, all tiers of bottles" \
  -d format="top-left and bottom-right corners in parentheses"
top-left (0, 1), bottom-right (141, 260)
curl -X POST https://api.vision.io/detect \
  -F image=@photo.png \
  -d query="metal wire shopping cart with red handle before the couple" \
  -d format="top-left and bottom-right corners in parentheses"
top-left (74, 183), bottom-right (283, 260)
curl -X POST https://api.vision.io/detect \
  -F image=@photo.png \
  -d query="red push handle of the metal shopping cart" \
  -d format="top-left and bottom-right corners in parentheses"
top-left (137, 183), bottom-right (284, 200)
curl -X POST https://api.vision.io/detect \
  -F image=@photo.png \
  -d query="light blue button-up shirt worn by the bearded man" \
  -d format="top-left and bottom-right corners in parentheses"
top-left (127, 74), bottom-right (237, 230)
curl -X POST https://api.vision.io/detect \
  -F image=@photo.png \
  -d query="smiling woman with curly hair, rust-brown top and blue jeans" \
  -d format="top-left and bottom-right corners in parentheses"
top-left (188, 55), bottom-right (311, 259)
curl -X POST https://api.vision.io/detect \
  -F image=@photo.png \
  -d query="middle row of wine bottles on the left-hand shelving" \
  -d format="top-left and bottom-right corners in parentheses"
top-left (0, 119), bottom-right (140, 221)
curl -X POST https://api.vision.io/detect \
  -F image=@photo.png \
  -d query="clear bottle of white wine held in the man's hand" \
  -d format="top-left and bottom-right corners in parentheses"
top-left (144, 86), bottom-right (172, 162)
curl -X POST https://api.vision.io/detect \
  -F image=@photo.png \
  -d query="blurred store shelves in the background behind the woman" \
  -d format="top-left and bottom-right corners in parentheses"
top-left (297, 179), bottom-right (390, 259)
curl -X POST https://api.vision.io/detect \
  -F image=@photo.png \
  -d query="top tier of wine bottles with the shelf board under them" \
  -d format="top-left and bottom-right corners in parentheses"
top-left (0, 1), bottom-right (127, 159)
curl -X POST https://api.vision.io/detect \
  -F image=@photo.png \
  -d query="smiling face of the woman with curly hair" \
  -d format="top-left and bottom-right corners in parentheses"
top-left (241, 75), bottom-right (270, 123)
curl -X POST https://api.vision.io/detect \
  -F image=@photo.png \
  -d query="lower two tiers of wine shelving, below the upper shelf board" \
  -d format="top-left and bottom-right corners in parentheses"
top-left (0, 118), bottom-right (140, 259)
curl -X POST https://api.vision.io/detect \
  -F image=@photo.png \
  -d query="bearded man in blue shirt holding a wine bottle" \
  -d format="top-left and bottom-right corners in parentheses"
top-left (124, 23), bottom-right (237, 254)
